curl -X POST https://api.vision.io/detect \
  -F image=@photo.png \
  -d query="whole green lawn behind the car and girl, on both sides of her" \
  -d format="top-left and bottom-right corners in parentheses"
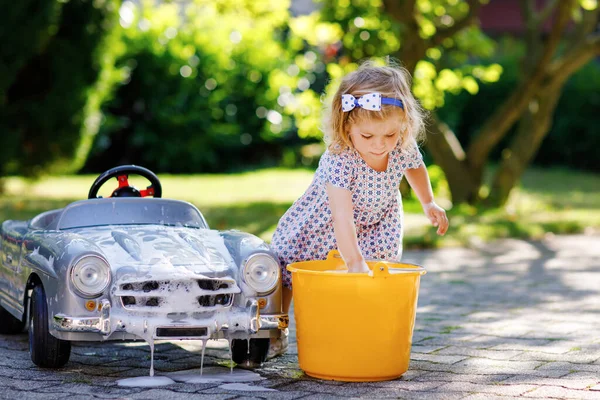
top-left (0, 168), bottom-right (600, 247)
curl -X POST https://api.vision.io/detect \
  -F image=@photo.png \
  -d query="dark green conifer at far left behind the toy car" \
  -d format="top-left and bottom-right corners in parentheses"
top-left (0, 0), bottom-right (118, 175)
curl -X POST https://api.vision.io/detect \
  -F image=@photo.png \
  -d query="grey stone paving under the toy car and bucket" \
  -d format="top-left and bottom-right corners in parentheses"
top-left (0, 235), bottom-right (600, 400)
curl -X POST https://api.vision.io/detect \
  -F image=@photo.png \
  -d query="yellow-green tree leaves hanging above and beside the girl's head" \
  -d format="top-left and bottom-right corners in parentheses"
top-left (291, 0), bottom-right (502, 121)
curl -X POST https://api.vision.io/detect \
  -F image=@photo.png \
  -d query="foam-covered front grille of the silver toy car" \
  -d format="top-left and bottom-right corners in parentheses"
top-left (115, 278), bottom-right (240, 311)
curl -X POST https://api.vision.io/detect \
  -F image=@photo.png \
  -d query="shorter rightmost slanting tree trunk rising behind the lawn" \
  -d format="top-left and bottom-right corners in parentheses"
top-left (486, 86), bottom-right (562, 207)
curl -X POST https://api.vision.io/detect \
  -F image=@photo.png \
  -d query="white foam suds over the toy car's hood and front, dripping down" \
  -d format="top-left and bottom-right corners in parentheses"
top-left (72, 226), bottom-right (276, 386)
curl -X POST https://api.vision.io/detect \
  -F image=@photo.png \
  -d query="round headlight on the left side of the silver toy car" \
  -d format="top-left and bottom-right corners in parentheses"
top-left (71, 256), bottom-right (110, 297)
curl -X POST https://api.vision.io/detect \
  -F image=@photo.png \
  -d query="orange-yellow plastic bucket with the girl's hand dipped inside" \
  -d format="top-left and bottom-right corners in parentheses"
top-left (287, 250), bottom-right (425, 382)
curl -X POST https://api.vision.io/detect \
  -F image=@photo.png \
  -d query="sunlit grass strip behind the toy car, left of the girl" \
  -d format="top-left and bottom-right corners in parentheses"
top-left (0, 169), bottom-right (313, 240)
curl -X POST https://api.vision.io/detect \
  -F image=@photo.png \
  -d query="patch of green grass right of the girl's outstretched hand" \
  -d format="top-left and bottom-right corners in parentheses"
top-left (438, 168), bottom-right (600, 247)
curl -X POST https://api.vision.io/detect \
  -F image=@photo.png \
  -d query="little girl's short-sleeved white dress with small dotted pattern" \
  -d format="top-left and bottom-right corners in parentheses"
top-left (271, 144), bottom-right (423, 288)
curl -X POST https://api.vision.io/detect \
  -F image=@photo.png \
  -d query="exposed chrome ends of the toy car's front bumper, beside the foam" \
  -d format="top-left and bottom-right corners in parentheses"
top-left (52, 299), bottom-right (289, 336)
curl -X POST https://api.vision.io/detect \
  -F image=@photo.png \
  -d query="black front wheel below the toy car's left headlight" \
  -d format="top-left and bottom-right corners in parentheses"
top-left (29, 285), bottom-right (71, 368)
